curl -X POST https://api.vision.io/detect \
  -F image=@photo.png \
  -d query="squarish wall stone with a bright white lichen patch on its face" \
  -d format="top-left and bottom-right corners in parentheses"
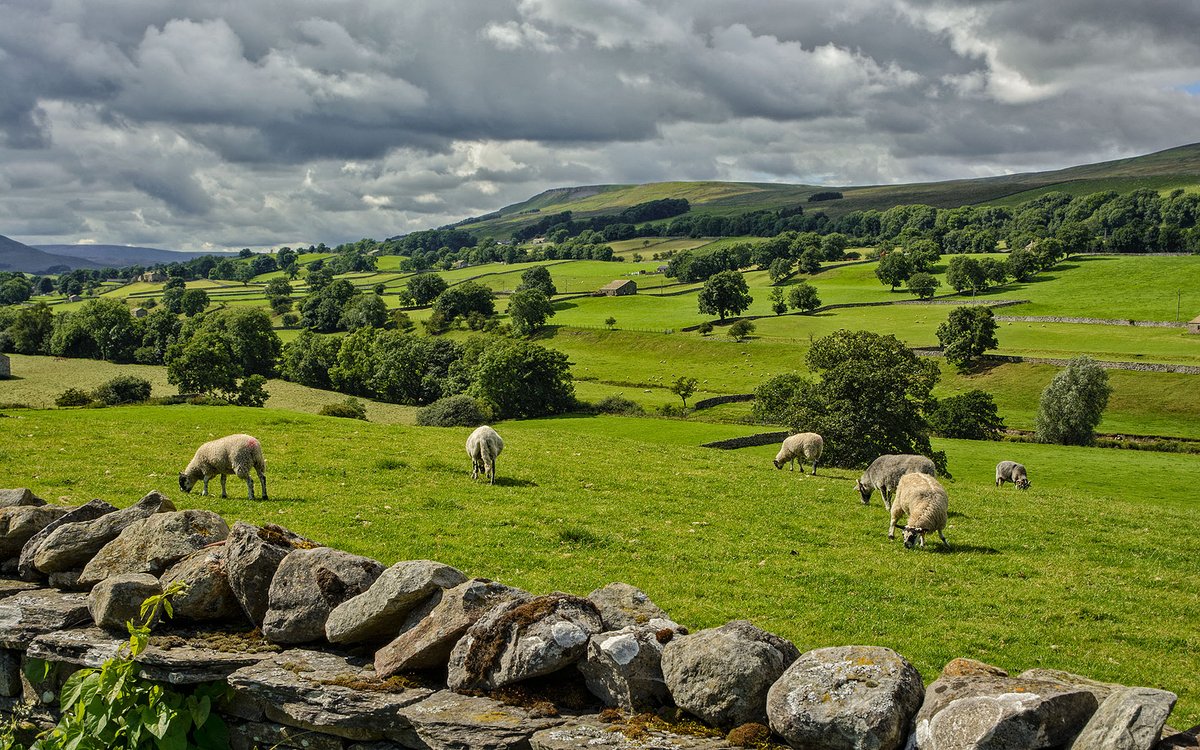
top-left (578, 619), bottom-right (678, 712)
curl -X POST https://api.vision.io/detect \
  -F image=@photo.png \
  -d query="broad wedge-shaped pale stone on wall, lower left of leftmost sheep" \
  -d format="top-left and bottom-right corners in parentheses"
top-left (79, 510), bottom-right (229, 586)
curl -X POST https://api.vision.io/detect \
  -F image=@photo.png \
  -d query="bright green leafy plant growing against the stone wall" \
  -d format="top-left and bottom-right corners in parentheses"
top-left (30, 581), bottom-right (229, 750)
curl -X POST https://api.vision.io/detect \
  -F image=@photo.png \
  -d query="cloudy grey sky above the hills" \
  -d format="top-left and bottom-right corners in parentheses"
top-left (0, 0), bottom-right (1200, 250)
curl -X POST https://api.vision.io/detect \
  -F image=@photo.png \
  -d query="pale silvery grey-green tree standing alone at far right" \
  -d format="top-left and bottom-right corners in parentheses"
top-left (1034, 356), bottom-right (1112, 445)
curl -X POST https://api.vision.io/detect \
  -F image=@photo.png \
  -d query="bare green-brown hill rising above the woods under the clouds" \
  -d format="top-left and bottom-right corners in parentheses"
top-left (456, 144), bottom-right (1200, 238)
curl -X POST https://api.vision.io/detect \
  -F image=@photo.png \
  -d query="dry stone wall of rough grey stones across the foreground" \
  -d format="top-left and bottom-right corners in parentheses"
top-left (0, 490), bottom-right (1198, 750)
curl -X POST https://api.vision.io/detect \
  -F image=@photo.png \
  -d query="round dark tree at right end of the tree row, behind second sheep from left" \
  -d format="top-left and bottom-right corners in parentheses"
top-left (469, 341), bottom-right (575, 419)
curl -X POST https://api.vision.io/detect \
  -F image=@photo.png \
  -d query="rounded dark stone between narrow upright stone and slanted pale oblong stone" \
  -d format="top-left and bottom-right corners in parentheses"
top-left (263, 547), bottom-right (383, 643)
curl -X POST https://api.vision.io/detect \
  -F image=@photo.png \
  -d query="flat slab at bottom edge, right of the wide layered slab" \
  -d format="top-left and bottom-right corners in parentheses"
top-left (388, 690), bottom-right (564, 750)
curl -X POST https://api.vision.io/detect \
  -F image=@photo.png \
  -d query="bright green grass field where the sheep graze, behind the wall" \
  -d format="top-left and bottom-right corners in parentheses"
top-left (0, 407), bottom-right (1200, 726)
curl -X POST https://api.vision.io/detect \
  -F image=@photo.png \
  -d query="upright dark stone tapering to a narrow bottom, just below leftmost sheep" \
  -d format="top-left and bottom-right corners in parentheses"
top-left (226, 521), bottom-right (320, 628)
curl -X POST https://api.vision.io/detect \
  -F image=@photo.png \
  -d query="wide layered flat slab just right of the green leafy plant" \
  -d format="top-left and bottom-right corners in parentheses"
top-left (228, 649), bottom-right (433, 740)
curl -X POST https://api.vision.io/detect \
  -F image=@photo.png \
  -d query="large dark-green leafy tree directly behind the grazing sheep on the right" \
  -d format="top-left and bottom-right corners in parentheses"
top-left (755, 330), bottom-right (946, 470)
